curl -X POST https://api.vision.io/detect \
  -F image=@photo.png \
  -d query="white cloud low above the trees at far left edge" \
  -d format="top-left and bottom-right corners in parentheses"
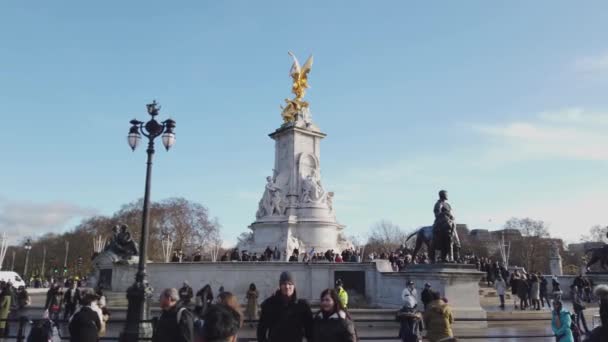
top-left (0, 198), bottom-right (97, 244)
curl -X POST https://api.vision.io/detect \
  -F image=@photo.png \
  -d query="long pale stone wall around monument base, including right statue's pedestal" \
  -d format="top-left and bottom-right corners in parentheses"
top-left (104, 260), bottom-right (486, 327)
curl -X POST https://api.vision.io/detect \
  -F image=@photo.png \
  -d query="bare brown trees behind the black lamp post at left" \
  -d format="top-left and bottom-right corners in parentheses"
top-left (2, 197), bottom-right (222, 277)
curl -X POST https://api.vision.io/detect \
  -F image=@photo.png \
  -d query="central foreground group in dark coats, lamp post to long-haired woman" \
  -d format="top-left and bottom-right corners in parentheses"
top-left (152, 272), bottom-right (357, 342)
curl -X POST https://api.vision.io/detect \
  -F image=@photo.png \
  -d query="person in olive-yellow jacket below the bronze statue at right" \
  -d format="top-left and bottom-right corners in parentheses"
top-left (422, 291), bottom-right (454, 342)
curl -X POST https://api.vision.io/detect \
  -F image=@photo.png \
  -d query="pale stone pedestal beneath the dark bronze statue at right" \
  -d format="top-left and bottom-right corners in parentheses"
top-left (403, 264), bottom-right (487, 328)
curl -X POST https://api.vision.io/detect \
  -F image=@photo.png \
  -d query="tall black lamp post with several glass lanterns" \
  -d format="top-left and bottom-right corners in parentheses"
top-left (120, 101), bottom-right (175, 342)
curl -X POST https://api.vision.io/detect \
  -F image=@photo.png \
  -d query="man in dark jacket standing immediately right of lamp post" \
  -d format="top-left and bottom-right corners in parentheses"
top-left (152, 288), bottom-right (194, 342)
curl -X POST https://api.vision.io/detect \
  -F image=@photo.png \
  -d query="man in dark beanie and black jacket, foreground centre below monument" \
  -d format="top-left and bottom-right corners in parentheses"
top-left (257, 272), bottom-right (312, 342)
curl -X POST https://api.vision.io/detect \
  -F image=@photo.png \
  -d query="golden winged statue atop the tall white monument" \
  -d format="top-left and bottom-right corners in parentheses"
top-left (281, 51), bottom-right (313, 123)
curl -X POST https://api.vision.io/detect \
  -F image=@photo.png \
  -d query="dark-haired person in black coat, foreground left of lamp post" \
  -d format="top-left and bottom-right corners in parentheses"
top-left (68, 293), bottom-right (102, 342)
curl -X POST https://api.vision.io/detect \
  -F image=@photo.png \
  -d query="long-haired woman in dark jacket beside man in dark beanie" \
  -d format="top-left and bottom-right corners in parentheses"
top-left (312, 289), bottom-right (357, 342)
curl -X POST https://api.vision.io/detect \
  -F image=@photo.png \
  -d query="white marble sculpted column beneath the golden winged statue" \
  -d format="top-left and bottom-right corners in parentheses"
top-left (244, 115), bottom-right (347, 254)
